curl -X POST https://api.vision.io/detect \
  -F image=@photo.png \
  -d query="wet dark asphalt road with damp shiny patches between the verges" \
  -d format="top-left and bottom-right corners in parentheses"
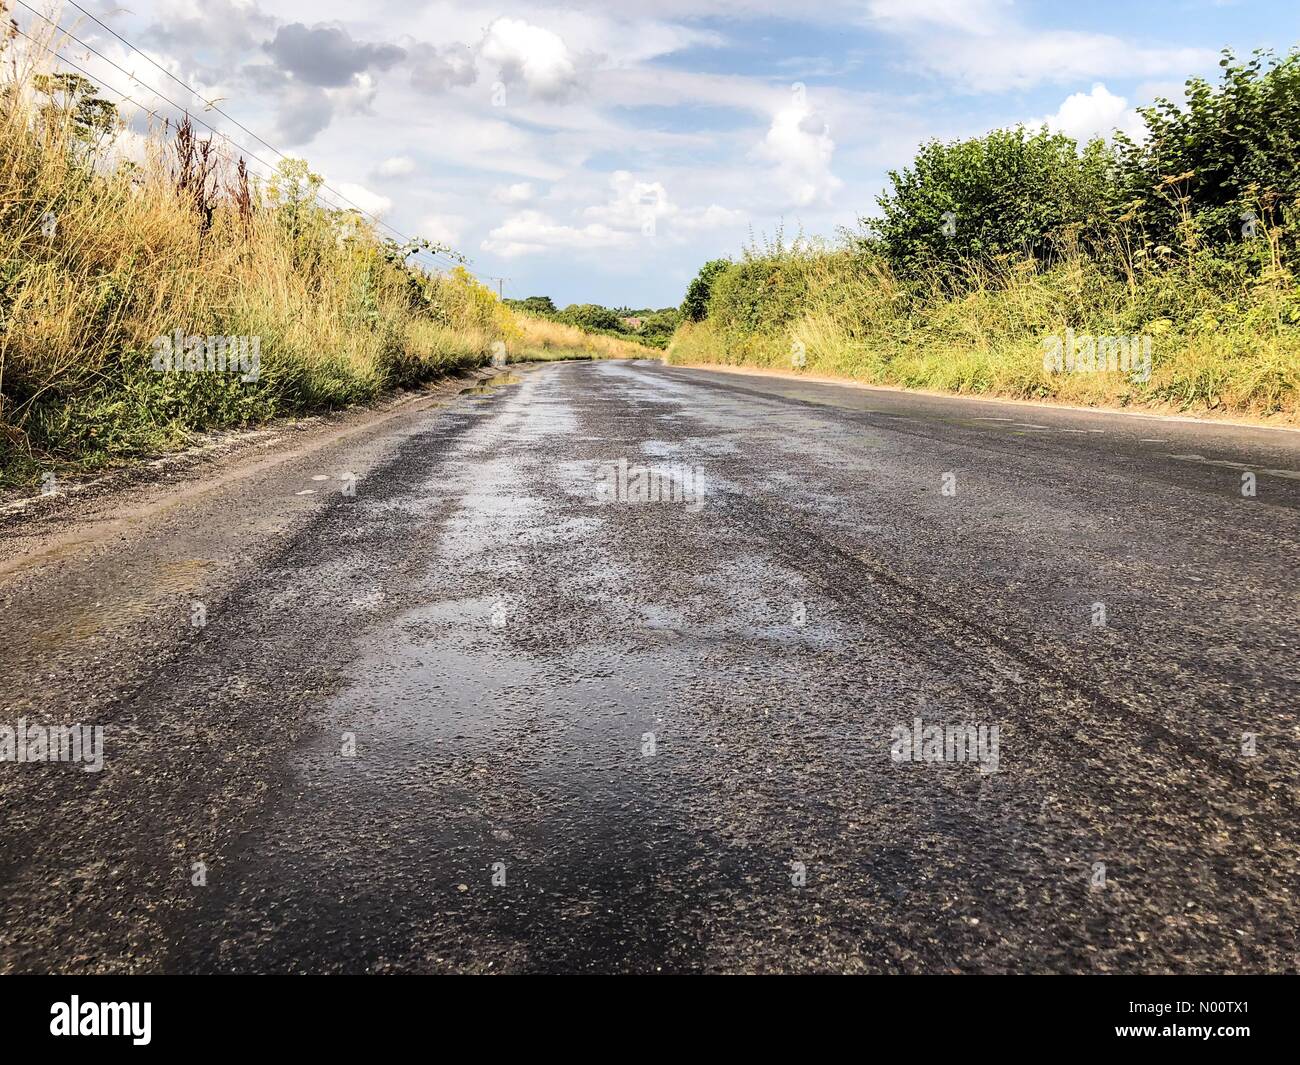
top-left (0, 363), bottom-right (1300, 973)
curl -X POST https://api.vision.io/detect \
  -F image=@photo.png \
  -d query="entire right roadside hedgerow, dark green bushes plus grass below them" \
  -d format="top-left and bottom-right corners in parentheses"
top-left (670, 49), bottom-right (1300, 423)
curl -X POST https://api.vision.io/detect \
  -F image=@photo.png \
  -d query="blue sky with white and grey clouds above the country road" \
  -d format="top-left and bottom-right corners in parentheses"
top-left (18, 0), bottom-right (1300, 307)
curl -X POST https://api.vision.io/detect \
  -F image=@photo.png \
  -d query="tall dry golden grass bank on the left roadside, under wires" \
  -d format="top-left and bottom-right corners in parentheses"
top-left (0, 13), bottom-right (626, 484)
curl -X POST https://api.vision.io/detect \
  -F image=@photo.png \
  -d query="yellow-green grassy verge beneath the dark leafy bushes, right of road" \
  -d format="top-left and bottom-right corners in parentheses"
top-left (668, 234), bottom-right (1300, 424)
